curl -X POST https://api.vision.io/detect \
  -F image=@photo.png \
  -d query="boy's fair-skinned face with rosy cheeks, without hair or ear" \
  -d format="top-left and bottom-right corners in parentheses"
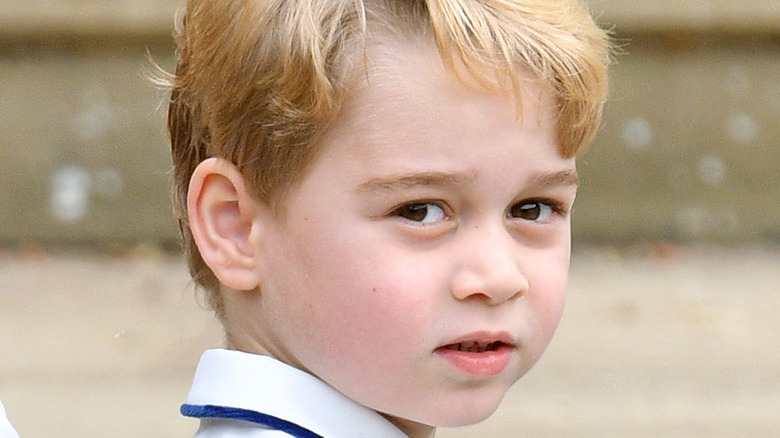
top-left (247, 40), bottom-right (576, 435)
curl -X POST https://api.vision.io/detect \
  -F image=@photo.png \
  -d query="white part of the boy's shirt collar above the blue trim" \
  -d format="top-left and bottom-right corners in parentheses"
top-left (187, 349), bottom-right (407, 438)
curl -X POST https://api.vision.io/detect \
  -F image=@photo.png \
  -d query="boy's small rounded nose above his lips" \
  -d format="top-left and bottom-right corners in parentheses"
top-left (450, 222), bottom-right (529, 305)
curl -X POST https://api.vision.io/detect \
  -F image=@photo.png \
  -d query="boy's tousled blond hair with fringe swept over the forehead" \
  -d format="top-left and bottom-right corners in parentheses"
top-left (168, 0), bottom-right (610, 318)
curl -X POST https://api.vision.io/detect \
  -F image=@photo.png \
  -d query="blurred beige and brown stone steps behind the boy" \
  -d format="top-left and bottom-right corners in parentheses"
top-left (0, 0), bottom-right (780, 438)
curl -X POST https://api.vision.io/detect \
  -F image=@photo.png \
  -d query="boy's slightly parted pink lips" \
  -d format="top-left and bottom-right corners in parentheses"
top-left (435, 332), bottom-right (516, 377)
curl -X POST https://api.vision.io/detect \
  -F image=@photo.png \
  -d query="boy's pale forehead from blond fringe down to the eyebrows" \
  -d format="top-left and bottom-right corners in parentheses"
top-left (290, 37), bottom-right (574, 198)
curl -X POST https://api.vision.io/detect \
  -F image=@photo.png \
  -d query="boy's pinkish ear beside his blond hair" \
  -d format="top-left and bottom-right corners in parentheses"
top-left (187, 158), bottom-right (261, 290)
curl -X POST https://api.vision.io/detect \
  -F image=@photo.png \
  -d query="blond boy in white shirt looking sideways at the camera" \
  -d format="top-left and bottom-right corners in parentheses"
top-left (169, 0), bottom-right (609, 438)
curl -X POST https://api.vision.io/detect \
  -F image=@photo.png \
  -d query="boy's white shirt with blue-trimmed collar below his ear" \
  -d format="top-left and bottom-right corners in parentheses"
top-left (181, 349), bottom-right (408, 438)
